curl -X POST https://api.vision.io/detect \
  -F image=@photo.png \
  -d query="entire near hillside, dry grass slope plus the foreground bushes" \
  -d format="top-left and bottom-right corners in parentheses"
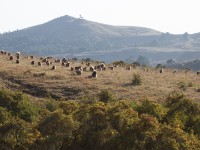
top-left (0, 51), bottom-right (200, 150)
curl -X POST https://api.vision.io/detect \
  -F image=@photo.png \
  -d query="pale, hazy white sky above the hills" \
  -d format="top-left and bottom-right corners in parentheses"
top-left (0, 0), bottom-right (200, 34)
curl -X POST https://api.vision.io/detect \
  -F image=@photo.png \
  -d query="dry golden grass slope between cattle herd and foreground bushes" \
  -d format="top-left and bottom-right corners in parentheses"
top-left (0, 51), bottom-right (200, 103)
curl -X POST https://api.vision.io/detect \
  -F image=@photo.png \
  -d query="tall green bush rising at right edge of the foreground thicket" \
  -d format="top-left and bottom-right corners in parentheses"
top-left (165, 93), bottom-right (200, 134)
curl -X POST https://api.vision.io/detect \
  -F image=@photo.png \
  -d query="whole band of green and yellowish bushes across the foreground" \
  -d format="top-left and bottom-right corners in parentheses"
top-left (0, 89), bottom-right (200, 150)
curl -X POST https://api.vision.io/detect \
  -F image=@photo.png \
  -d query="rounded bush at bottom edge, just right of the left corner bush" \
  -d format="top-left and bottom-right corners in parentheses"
top-left (35, 112), bottom-right (77, 149)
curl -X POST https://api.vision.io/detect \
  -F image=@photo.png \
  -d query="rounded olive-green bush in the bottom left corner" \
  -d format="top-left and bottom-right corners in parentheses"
top-left (0, 118), bottom-right (39, 150)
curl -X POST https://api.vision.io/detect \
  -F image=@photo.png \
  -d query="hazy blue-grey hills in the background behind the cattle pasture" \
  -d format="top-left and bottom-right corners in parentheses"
top-left (0, 15), bottom-right (200, 64)
